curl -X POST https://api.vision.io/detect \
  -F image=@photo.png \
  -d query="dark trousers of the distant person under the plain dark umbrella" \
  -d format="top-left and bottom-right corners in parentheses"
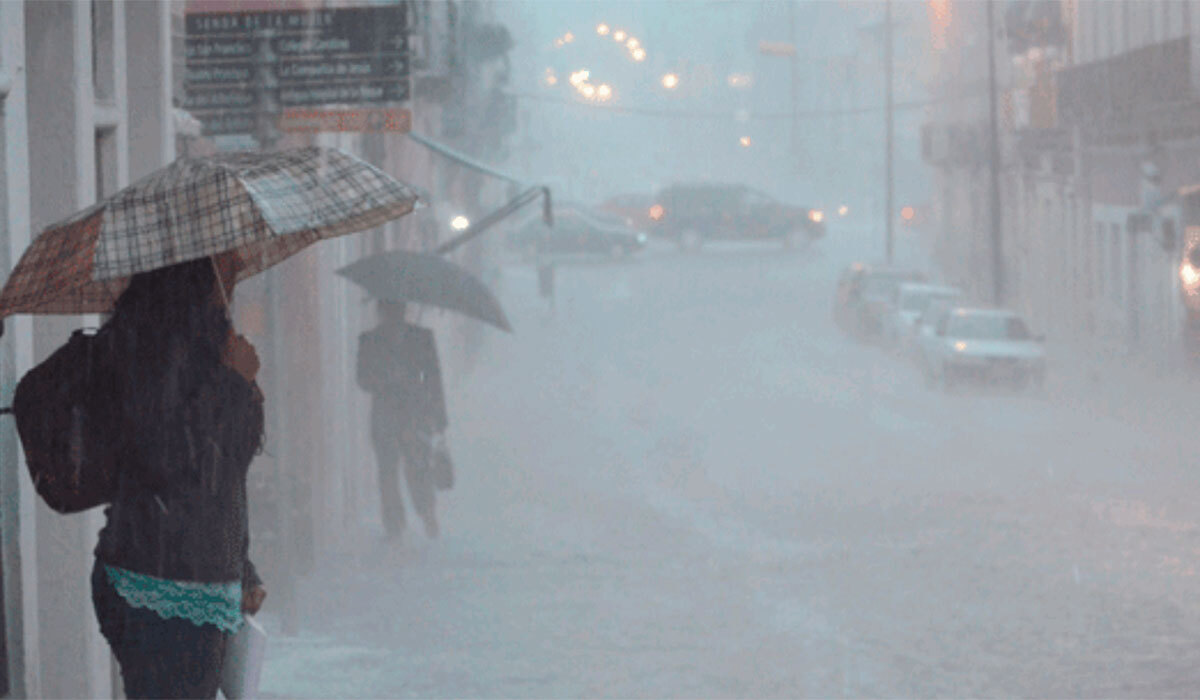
top-left (371, 420), bottom-right (437, 534)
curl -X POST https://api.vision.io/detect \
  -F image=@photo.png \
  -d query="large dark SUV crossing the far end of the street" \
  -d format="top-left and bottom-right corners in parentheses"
top-left (648, 183), bottom-right (826, 250)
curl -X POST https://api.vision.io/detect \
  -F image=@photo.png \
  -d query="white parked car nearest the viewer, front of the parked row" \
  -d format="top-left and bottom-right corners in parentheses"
top-left (922, 307), bottom-right (1046, 390)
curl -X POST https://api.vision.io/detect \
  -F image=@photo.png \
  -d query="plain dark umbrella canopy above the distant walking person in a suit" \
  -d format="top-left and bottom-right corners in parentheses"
top-left (337, 251), bottom-right (512, 333)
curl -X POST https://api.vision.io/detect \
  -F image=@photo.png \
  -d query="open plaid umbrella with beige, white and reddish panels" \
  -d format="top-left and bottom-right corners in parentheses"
top-left (0, 146), bottom-right (418, 318)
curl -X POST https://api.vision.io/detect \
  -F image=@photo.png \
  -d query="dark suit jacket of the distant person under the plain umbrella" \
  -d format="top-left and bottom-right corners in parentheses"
top-left (358, 323), bottom-right (448, 432)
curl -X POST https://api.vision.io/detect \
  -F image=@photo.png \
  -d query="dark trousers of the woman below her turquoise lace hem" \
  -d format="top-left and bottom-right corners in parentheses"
top-left (91, 560), bottom-right (227, 698)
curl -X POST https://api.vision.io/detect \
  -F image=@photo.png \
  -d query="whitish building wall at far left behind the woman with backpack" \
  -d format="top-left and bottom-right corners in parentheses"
top-left (0, 0), bottom-right (174, 698)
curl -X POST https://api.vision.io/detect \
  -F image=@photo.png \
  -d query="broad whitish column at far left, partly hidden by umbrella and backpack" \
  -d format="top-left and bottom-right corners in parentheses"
top-left (25, 0), bottom-right (110, 698)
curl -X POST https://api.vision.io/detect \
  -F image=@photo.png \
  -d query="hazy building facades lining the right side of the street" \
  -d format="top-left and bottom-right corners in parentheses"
top-left (925, 0), bottom-right (1200, 367)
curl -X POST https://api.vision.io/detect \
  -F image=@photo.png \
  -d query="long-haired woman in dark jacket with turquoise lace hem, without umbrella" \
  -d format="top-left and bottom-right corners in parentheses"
top-left (91, 259), bottom-right (266, 698)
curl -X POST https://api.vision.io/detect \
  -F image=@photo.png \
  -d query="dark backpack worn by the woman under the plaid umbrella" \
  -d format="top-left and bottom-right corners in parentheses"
top-left (12, 330), bottom-right (120, 513)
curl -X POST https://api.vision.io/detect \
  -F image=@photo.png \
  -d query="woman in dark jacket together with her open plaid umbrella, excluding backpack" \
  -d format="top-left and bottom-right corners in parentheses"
top-left (0, 146), bottom-right (416, 698)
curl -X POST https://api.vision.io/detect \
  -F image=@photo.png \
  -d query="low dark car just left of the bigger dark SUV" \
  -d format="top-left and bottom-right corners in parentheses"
top-left (509, 205), bottom-right (647, 258)
